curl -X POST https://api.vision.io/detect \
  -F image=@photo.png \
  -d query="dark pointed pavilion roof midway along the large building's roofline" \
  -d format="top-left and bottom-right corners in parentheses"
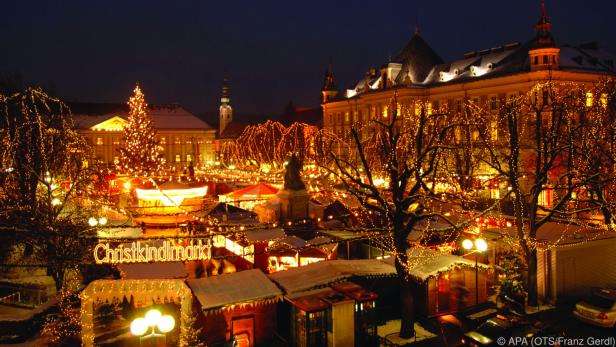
top-left (395, 32), bottom-right (443, 83)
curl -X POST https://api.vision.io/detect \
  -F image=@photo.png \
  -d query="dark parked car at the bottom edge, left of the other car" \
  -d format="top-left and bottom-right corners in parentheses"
top-left (460, 315), bottom-right (539, 347)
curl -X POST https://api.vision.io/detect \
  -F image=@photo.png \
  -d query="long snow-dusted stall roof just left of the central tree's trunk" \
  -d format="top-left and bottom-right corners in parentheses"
top-left (269, 259), bottom-right (396, 294)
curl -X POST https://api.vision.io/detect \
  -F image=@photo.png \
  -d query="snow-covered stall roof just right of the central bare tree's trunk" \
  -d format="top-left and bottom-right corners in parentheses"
top-left (400, 247), bottom-right (489, 281)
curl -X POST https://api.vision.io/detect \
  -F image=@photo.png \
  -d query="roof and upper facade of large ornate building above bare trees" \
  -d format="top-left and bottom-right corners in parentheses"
top-left (321, 1), bottom-right (616, 140)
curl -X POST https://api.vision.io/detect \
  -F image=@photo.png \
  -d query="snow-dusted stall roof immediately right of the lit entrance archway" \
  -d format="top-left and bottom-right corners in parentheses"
top-left (186, 269), bottom-right (282, 311)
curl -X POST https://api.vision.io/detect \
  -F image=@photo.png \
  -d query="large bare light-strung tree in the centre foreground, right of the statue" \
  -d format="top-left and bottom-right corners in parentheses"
top-left (321, 97), bottom-right (500, 338)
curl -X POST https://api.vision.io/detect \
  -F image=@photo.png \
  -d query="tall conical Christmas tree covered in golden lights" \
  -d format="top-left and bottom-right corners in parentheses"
top-left (118, 85), bottom-right (164, 175)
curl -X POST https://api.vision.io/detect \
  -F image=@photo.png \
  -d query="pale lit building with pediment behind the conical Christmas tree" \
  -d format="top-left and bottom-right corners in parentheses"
top-left (69, 103), bottom-right (216, 169)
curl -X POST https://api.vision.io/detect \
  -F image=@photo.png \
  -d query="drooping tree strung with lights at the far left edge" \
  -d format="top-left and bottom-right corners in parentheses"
top-left (0, 89), bottom-right (103, 290)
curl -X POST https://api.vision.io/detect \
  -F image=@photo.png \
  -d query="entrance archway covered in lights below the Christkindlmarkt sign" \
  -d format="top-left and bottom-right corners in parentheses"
top-left (81, 280), bottom-right (192, 347)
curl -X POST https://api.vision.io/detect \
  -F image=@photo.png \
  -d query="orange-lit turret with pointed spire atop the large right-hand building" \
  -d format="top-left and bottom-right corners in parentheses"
top-left (528, 0), bottom-right (560, 71)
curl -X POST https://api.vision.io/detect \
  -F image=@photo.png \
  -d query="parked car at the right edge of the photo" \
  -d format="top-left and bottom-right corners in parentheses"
top-left (573, 288), bottom-right (616, 328)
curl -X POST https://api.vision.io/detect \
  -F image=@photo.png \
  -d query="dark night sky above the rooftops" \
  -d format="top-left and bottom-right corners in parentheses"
top-left (0, 0), bottom-right (616, 122)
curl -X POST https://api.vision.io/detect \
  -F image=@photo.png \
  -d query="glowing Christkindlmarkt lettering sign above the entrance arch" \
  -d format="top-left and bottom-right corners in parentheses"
top-left (94, 240), bottom-right (211, 264)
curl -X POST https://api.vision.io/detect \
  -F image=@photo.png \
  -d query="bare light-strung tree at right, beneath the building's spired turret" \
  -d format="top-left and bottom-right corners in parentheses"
top-left (476, 81), bottom-right (585, 306)
